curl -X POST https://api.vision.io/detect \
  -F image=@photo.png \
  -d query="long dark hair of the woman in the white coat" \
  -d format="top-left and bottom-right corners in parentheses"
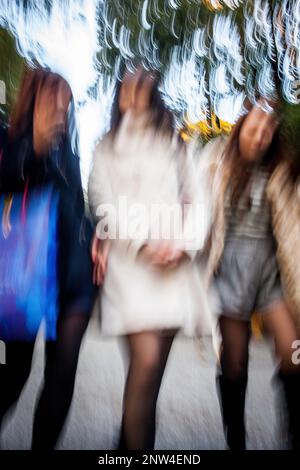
top-left (110, 67), bottom-right (175, 137)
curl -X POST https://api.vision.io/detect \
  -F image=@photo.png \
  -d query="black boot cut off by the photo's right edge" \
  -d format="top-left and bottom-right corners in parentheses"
top-left (278, 372), bottom-right (300, 450)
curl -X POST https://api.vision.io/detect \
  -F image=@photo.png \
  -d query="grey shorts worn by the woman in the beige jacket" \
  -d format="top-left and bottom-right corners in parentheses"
top-left (214, 236), bottom-right (283, 321)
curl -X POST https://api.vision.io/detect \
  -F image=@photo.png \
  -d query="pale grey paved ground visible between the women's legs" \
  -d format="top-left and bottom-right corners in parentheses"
top-left (1, 322), bottom-right (284, 449)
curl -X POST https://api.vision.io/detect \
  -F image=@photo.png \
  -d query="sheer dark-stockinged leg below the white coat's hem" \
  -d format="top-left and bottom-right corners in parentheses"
top-left (119, 331), bottom-right (175, 450)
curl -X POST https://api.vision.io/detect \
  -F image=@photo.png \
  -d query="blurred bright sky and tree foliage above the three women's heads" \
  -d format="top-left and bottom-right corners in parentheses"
top-left (0, 0), bottom-right (300, 186)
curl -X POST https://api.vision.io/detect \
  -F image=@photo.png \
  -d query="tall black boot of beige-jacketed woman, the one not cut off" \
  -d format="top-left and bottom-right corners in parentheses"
top-left (217, 374), bottom-right (248, 450)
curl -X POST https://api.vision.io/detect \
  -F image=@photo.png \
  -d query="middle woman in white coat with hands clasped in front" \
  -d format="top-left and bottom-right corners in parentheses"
top-left (89, 68), bottom-right (210, 449)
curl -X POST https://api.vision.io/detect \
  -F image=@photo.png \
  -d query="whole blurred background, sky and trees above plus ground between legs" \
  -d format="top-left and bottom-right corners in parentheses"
top-left (0, 0), bottom-right (300, 449)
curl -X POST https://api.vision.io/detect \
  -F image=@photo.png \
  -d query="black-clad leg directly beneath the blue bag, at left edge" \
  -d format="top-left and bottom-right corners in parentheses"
top-left (0, 342), bottom-right (34, 428)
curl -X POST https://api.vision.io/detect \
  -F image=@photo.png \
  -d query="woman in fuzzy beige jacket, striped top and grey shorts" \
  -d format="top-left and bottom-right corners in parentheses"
top-left (202, 100), bottom-right (300, 449)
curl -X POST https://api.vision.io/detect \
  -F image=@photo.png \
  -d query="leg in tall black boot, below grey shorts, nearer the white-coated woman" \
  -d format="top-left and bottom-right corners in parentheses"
top-left (217, 316), bottom-right (250, 450)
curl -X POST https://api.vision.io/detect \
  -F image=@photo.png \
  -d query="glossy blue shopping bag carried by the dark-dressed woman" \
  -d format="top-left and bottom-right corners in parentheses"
top-left (0, 185), bottom-right (58, 341)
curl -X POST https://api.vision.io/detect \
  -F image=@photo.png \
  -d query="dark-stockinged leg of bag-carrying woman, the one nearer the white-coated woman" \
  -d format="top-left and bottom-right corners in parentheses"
top-left (32, 314), bottom-right (89, 450)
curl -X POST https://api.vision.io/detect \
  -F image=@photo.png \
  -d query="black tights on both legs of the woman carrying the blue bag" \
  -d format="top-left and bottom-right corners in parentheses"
top-left (0, 314), bottom-right (89, 450)
